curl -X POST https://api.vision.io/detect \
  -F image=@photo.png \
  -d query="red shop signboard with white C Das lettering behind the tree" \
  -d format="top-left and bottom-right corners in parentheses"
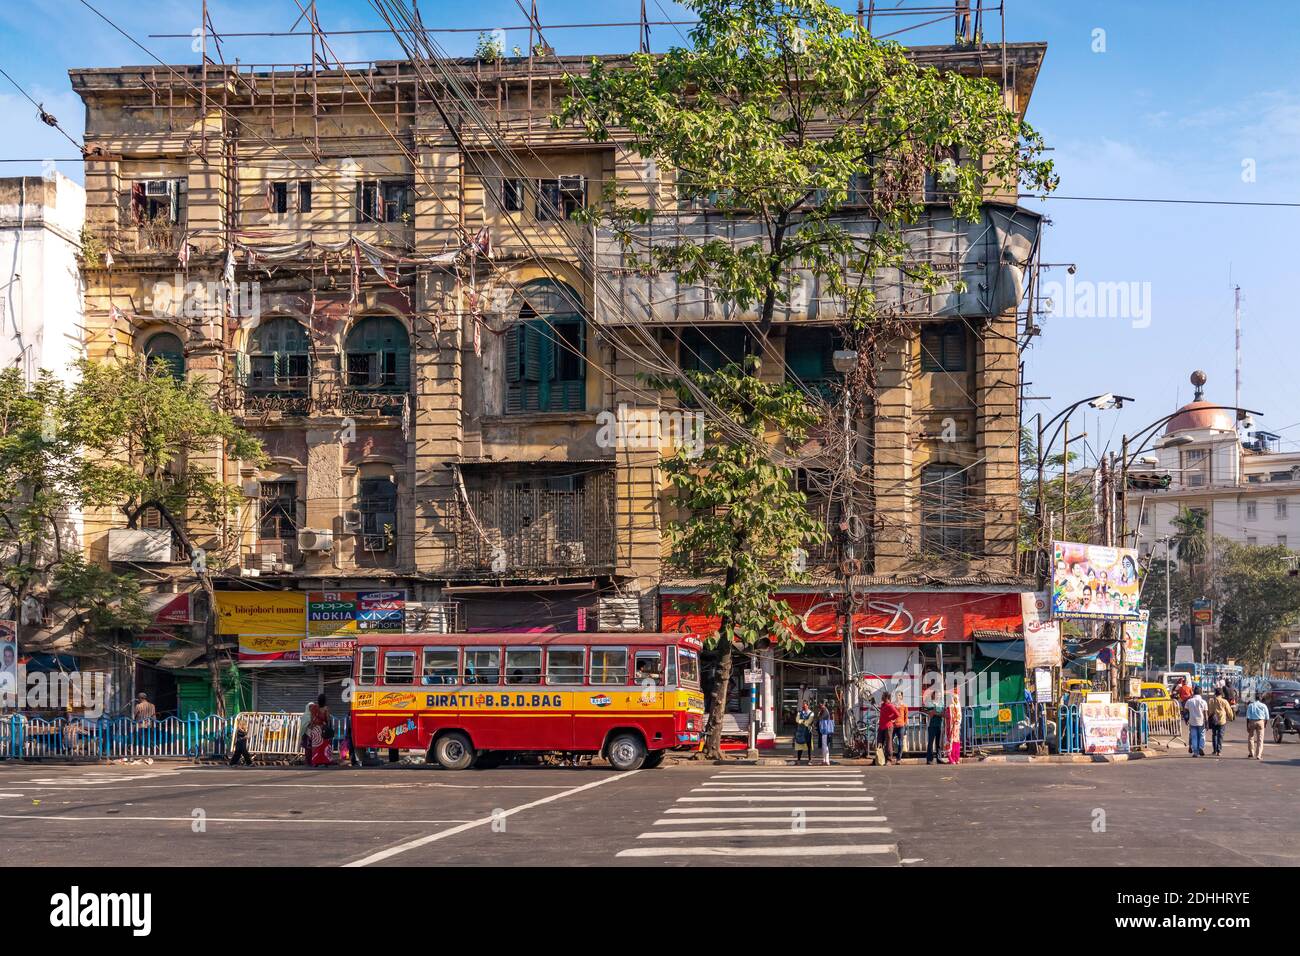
top-left (663, 591), bottom-right (1022, 644)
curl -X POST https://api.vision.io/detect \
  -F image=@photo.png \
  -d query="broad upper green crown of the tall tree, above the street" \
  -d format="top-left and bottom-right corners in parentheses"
top-left (554, 0), bottom-right (1056, 364)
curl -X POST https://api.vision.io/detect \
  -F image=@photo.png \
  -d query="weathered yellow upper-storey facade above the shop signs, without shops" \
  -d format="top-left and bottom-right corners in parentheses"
top-left (72, 44), bottom-right (1043, 676)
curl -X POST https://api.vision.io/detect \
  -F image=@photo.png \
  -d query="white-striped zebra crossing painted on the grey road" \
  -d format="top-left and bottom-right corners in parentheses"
top-left (615, 766), bottom-right (898, 866)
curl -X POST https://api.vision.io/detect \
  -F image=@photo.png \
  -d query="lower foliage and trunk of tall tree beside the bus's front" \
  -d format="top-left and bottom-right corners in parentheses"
top-left (655, 359), bottom-right (827, 757)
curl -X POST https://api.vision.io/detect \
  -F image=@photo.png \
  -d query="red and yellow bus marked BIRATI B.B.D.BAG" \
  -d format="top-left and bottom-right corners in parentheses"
top-left (352, 632), bottom-right (705, 770)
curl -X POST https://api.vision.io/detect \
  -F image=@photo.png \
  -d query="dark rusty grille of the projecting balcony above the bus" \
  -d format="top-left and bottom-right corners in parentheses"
top-left (449, 472), bottom-right (615, 576)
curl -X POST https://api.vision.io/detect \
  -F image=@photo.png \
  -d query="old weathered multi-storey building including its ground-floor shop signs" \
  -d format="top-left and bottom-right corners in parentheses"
top-left (72, 37), bottom-right (1044, 736)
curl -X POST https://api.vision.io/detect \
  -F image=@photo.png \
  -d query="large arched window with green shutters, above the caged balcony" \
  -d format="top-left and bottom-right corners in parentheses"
top-left (506, 278), bottom-right (586, 412)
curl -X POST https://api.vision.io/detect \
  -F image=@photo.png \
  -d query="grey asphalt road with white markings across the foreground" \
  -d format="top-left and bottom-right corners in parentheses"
top-left (0, 721), bottom-right (1300, 866)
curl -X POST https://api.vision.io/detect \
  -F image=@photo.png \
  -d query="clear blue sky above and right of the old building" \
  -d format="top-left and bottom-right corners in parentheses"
top-left (0, 0), bottom-right (1300, 460)
